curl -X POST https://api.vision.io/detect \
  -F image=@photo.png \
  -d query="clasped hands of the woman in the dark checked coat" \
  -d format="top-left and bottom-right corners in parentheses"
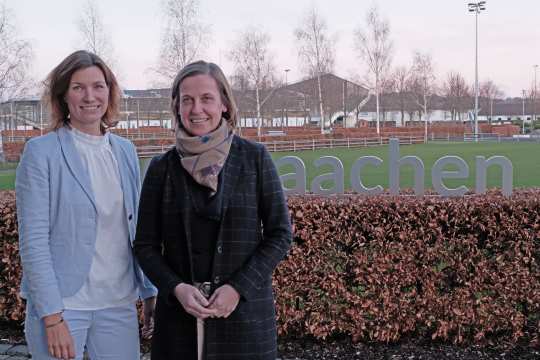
top-left (174, 283), bottom-right (240, 319)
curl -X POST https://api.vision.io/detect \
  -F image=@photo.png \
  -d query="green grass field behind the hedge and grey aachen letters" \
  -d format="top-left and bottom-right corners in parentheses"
top-left (0, 142), bottom-right (540, 190)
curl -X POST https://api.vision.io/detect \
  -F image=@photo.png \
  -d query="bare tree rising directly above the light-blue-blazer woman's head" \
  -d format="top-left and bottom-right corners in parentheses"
top-left (77, 0), bottom-right (115, 67)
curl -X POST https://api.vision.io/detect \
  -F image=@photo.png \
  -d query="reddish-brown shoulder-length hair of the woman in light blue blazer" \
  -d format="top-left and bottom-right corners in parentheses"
top-left (43, 50), bottom-right (121, 133)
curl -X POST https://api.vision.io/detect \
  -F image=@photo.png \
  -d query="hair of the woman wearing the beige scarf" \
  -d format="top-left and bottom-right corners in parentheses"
top-left (171, 60), bottom-right (238, 129)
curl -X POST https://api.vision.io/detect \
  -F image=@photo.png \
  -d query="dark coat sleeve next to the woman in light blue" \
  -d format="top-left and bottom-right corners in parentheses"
top-left (133, 157), bottom-right (183, 298)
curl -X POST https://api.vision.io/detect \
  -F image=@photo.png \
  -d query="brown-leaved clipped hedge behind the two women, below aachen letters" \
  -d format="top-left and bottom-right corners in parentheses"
top-left (0, 189), bottom-right (540, 345)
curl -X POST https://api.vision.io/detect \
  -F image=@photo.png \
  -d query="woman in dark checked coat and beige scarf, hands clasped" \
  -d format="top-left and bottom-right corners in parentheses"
top-left (135, 61), bottom-right (291, 360)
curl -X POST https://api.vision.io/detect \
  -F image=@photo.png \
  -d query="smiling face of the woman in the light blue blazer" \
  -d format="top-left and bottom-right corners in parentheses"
top-left (64, 66), bottom-right (109, 135)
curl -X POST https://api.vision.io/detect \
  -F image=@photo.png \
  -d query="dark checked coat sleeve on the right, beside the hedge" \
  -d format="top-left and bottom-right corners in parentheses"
top-left (229, 147), bottom-right (292, 300)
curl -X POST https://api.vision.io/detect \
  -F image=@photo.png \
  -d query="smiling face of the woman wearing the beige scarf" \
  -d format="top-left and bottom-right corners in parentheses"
top-left (178, 74), bottom-right (227, 136)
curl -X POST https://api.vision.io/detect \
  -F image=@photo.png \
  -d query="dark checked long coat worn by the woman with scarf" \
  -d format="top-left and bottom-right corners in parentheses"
top-left (134, 136), bottom-right (291, 360)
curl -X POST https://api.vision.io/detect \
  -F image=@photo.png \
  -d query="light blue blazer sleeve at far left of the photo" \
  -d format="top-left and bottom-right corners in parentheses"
top-left (15, 140), bottom-right (64, 318)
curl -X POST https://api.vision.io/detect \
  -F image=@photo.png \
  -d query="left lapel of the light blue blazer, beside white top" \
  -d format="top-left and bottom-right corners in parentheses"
top-left (57, 127), bottom-right (97, 211)
